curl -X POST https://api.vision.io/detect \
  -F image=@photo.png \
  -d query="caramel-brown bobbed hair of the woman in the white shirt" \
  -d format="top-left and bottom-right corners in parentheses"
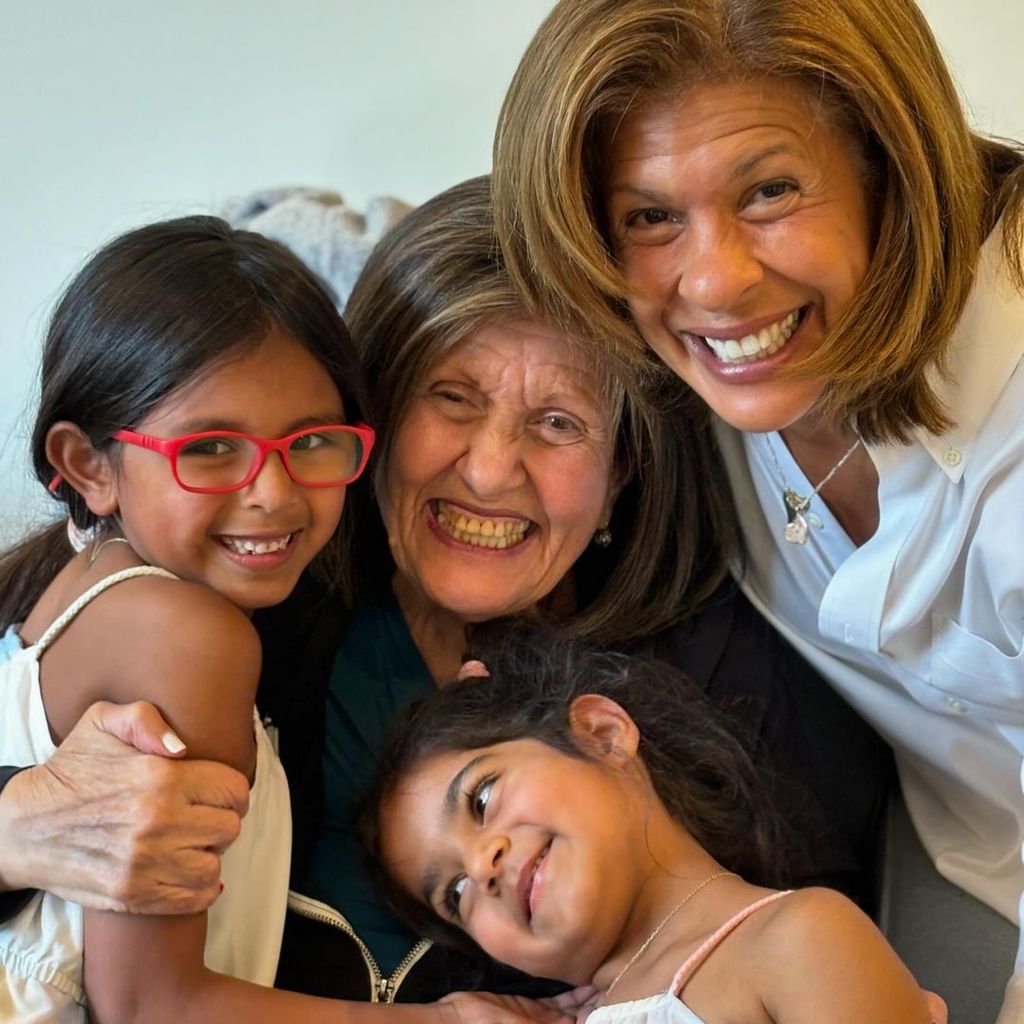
top-left (494, 0), bottom-right (1024, 441)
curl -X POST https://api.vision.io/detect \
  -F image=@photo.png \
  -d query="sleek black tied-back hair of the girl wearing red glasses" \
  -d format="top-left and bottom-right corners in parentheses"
top-left (0, 216), bottom-right (370, 627)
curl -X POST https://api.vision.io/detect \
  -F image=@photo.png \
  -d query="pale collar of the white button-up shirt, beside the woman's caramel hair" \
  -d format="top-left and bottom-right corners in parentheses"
top-left (913, 226), bottom-right (1024, 483)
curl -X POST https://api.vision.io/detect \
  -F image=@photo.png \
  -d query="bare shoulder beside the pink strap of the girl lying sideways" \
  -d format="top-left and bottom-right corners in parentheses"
top-left (755, 888), bottom-right (929, 1024)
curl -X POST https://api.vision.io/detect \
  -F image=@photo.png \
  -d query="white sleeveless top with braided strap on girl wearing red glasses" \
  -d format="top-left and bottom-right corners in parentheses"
top-left (0, 565), bottom-right (292, 1024)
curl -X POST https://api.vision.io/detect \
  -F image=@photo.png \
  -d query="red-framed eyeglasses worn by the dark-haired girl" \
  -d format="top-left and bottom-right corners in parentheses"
top-left (50, 423), bottom-right (376, 495)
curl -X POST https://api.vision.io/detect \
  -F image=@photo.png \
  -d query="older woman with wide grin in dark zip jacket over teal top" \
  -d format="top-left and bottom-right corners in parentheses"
top-left (0, 179), bottom-right (888, 1019)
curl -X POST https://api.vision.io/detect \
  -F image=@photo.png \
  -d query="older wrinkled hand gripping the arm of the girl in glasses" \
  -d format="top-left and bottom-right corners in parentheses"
top-left (0, 702), bottom-right (249, 913)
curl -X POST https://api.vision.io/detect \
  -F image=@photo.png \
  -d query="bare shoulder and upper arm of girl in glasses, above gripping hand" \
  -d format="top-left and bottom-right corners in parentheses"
top-left (41, 575), bottom-right (260, 772)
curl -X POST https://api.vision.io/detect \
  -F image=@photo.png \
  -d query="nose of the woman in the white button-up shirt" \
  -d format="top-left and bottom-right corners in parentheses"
top-left (678, 217), bottom-right (765, 313)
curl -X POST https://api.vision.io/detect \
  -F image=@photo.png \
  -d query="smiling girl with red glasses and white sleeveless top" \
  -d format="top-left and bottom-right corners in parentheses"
top-left (0, 217), bottom-right (374, 1022)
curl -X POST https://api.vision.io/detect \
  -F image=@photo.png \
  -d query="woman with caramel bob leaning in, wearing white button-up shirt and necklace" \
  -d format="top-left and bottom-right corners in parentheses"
top-left (495, 0), bottom-right (1024, 1021)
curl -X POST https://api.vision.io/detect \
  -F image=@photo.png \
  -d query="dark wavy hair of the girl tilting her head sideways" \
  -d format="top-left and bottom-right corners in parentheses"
top-left (360, 618), bottom-right (788, 947)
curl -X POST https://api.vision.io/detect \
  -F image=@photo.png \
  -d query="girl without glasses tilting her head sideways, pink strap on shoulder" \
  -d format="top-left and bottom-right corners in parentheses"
top-left (365, 621), bottom-right (946, 1024)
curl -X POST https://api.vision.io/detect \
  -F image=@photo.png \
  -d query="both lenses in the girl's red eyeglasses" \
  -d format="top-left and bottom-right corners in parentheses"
top-left (177, 427), bottom-right (362, 487)
